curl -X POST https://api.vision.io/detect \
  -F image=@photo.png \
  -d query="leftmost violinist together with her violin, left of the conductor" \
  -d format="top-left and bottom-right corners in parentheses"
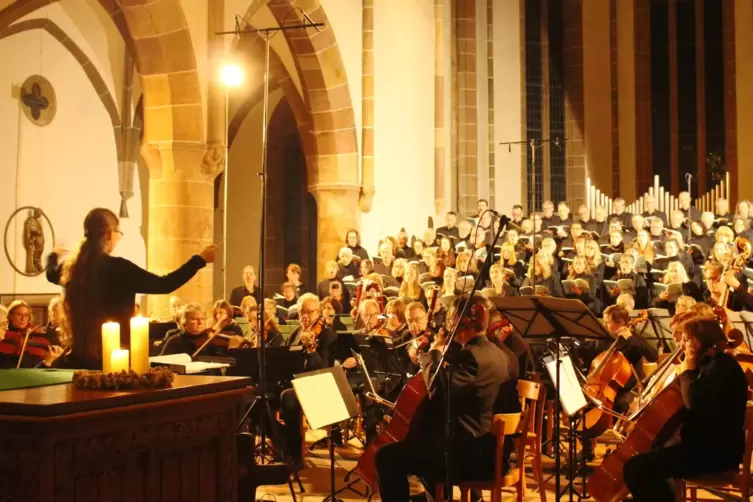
top-left (0, 300), bottom-right (63, 368)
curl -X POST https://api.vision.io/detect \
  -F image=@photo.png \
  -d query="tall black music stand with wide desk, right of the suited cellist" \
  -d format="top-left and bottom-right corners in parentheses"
top-left (490, 296), bottom-right (611, 501)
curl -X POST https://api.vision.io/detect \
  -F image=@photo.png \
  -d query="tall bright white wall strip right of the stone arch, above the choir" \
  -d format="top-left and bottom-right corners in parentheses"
top-left (358, 0), bottom-right (434, 253)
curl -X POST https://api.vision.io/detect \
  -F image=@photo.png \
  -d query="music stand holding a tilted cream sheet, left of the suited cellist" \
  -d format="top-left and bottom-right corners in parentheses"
top-left (293, 366), bottom-right (358, 502)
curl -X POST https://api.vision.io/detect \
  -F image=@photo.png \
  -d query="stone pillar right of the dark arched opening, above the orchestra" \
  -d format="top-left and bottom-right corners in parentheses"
top-left (309, 182), bottom-right (360, 273)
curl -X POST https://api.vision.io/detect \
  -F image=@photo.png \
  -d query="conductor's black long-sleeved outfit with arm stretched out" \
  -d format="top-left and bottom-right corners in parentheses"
top-left (47, 253), bottom-right (206, 368)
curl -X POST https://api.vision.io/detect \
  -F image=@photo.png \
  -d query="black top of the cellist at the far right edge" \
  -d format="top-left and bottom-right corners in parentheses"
top-left (678, 353), bottom-right (748, 462)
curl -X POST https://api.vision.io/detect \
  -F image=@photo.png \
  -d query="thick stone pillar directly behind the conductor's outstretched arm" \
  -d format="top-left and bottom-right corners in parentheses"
top-left (142, 143), bottom-right (217, 317)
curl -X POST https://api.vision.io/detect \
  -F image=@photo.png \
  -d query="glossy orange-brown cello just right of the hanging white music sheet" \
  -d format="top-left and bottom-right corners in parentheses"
top-left (582, 328), bottom-right (633, 436)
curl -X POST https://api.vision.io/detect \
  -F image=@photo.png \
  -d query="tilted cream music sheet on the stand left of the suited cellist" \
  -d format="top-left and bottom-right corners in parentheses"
top-left (292, 373), bottom-right (350, 429)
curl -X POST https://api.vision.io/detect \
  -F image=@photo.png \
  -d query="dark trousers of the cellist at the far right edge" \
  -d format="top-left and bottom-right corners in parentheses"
top-left (623, 445), bottom-right (737, 502)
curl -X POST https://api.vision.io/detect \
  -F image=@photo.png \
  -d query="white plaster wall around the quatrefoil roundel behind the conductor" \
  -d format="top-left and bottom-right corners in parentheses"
top-left (0, 27), bottom-right (146, 294)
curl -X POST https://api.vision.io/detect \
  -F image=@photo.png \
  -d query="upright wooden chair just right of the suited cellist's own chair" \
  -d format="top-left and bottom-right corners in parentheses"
top-left (518, 380), bottom-right (546, 502)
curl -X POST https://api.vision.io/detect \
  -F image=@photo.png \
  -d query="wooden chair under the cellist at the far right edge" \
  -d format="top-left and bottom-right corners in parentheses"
top-left (677, 402), bottom-right (753, 502)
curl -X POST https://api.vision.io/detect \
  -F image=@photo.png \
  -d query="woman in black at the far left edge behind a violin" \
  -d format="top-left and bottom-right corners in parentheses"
top-left (0, 300), bottom-right (63, 369)
